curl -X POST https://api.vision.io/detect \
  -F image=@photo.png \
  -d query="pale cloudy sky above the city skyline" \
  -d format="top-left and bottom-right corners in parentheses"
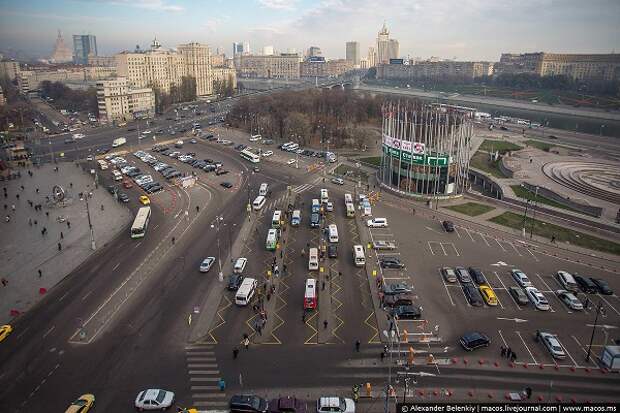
top-left (0, 0), bottom-right (620, 61)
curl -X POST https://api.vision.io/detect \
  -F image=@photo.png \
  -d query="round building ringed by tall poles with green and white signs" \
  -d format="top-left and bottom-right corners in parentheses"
top-left (378, 101), bottom-right (475, 199)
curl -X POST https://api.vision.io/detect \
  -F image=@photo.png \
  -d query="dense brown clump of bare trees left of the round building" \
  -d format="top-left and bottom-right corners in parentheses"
top-left (228, 89), bottom-right (383, 148)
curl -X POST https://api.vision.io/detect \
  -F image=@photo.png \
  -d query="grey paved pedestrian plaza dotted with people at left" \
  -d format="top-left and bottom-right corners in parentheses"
top-left (0, 163), bottom-right (131, 323)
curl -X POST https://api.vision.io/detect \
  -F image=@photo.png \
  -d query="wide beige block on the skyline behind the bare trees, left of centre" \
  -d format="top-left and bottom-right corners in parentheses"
top-left (237, 53), bottom-right (299, 79)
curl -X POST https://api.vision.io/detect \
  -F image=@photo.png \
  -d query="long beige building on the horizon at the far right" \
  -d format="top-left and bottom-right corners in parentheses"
top-left (497, 52), bottom-right (620, 80)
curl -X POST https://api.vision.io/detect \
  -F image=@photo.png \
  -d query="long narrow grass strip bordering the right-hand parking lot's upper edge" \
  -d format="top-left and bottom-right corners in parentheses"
top-left (489, 212), bottom-right (620, 255)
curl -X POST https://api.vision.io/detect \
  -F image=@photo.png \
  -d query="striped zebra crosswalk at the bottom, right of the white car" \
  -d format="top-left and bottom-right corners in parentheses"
top-left (185, 345), bottom-right (228, 410)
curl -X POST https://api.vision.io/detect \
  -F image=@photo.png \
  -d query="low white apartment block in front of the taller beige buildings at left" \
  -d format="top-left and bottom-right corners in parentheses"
top-left (97, 77), bottom-right (155, 122)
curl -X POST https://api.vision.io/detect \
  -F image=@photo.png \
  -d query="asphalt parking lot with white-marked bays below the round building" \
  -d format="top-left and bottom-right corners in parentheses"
top-left (360, 203), bottom-right (620, 370)
